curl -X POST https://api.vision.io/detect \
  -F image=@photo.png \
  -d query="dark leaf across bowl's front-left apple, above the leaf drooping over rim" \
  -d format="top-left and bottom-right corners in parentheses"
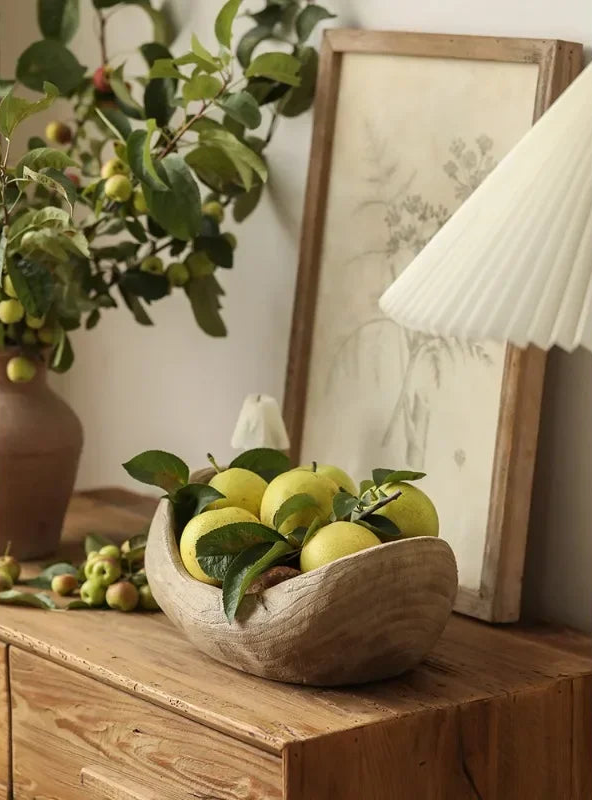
top-left (195, 523), bottom-right (286, 581)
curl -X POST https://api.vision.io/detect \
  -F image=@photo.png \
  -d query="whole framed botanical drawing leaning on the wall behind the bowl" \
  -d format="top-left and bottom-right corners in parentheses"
top-left (284, 30), bottom-right (582, 621)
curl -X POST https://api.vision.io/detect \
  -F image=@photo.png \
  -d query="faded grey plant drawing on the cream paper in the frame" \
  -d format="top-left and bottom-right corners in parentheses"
top-left (329, 126), bottom-right (496, 469)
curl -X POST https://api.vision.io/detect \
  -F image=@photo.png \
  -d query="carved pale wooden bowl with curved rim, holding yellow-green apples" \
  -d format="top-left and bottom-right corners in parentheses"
top-left (145, 500), bottom-right (457, 686)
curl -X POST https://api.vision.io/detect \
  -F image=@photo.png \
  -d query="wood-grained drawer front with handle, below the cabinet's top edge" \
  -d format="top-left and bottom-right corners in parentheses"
top-left (10, 648), bottom-right (282, 799)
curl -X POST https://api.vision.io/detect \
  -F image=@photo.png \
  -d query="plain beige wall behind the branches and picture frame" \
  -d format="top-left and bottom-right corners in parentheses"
top-left (0, 0), bottom-right (592, 630)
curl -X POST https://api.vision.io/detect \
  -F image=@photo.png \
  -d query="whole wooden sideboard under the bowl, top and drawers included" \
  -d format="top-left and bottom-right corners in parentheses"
top-left (0, 490), bottom-right (592, 799)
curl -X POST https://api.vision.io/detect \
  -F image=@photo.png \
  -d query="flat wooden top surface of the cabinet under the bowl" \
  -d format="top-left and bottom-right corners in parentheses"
top-left (0, 490), bottom-right (592, 753)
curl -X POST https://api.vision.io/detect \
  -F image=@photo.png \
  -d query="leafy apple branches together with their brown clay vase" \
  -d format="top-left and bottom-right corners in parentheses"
top-left (0, 0), bottom-right (332, 559)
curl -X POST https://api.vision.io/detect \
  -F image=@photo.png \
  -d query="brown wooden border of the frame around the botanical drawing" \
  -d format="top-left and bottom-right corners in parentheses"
top-left (284, 29), bottom-right (582, 622)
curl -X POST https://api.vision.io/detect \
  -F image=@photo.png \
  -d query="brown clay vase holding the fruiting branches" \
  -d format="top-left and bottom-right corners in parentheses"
top-left (0, 349), bottom-right (82, 560)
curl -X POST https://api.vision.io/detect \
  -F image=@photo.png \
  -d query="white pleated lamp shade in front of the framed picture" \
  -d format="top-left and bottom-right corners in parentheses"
top-left (380, 65), bottom-right (592, 351)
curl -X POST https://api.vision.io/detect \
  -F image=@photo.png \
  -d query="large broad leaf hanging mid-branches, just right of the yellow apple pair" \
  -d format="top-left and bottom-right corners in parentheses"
top-left (144, 153), bottom-right (201, 241)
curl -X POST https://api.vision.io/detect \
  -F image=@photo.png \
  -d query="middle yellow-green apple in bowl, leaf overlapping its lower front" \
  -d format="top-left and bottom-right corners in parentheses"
top-left (261, 470), bottom-right (339, 534)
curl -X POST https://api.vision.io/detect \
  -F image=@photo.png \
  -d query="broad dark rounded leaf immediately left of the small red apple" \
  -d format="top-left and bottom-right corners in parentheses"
top-left (16, 39), bottom-right (86, 95)
